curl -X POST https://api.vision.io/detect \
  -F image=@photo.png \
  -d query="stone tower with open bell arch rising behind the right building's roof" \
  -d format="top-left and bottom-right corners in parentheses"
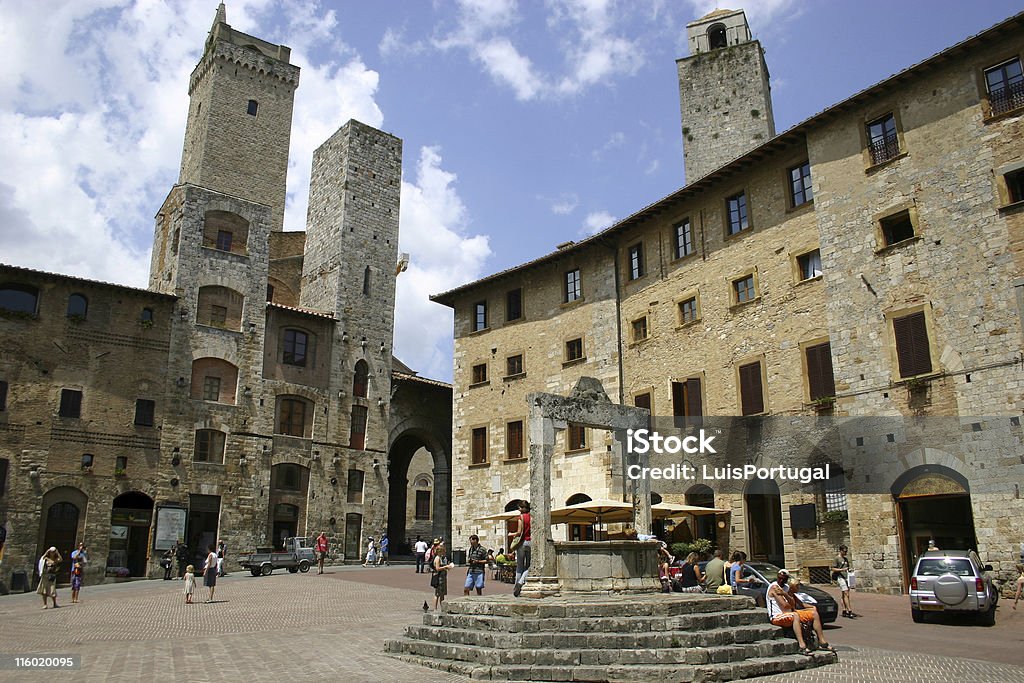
top-left (676, 9), bottom-right (775, 183)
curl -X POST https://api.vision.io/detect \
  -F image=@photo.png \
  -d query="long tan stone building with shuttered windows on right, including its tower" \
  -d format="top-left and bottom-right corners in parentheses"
top-left (434, 10), bottom-right (1024, 592)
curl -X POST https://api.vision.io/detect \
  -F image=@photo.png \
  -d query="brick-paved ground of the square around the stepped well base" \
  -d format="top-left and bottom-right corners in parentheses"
top-left (0, 566), bottom-right (1024, 683)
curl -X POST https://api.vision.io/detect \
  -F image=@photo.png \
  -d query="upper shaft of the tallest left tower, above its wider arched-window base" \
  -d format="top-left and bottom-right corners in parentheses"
top-left (178, 3), bottom-right (299, 230)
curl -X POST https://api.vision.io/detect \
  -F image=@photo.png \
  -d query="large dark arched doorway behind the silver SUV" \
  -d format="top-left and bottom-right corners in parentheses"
top-left (891, 465), bottom-right (978, 586)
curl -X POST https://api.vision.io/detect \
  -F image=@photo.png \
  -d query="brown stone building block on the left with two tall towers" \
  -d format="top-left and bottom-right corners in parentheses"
top-left (0, 4), bottom-right (451, 581)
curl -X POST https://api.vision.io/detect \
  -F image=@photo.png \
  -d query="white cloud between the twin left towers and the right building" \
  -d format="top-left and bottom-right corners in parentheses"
top-left (394, 147), bottom-right (490, 381)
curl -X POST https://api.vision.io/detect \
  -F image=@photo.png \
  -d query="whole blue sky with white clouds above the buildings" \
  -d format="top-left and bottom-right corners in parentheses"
top-left (0, 0), bottom-right (1020, 380)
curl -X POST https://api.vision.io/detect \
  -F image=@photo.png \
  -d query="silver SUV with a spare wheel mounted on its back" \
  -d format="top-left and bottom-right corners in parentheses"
top-left (910, 550), bottom-right (999, 626)
